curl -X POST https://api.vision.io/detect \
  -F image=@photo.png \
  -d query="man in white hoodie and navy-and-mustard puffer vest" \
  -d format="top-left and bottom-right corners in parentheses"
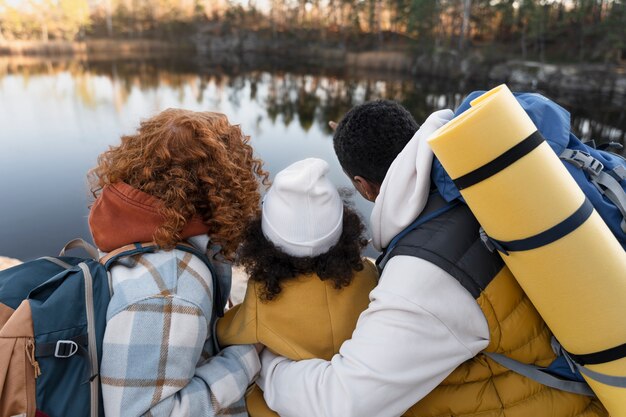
top-left (257, 100), bottom-right (605, 417)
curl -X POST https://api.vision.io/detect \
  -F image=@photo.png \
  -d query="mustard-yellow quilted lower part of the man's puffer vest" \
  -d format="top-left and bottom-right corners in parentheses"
top-left (404, 266), bottom-right (608, 417)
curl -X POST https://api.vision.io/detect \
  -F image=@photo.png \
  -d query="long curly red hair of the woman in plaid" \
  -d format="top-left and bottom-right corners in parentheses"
top-left (89, 109), bottom-right (268, 259)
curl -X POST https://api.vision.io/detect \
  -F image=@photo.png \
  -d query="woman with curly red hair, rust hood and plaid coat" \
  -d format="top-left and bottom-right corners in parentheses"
top-left (89, 109), bottom-right (267, 416)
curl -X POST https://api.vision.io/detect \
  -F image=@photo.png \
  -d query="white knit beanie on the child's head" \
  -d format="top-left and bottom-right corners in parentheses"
top-left (261, 158), bottom-right (343, 258)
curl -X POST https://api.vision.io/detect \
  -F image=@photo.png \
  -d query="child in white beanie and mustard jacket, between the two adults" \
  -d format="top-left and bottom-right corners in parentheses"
top-left (217, 158), bottom-right (378, 417)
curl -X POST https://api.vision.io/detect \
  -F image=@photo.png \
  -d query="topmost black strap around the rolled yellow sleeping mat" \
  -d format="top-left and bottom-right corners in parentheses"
top-left (454, 130), bottom-right (544, 190)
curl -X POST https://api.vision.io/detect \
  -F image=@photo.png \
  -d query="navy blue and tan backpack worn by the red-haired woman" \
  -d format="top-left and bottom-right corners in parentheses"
top-left (0, 239), bottom-right (225, 417)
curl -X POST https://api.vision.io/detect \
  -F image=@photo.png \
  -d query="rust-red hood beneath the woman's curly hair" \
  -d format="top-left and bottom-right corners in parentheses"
top-left (89, 182), bottom-right (208, 252)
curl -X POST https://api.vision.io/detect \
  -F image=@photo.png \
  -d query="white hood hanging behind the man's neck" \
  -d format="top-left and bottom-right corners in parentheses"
top-left (370, 109), bottom-right (454, 251)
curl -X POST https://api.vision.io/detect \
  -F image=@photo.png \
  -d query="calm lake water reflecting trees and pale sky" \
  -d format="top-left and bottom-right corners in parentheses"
top-left (0, 58), bottom-right (626, 259)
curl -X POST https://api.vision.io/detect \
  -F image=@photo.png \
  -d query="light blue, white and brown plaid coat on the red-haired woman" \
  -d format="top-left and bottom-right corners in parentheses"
top-left (101, 236), bottom-right (260, 417)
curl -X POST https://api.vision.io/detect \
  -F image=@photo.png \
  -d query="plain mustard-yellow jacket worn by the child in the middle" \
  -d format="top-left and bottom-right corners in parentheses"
top-left (217, 260), bottom-right (378, 417)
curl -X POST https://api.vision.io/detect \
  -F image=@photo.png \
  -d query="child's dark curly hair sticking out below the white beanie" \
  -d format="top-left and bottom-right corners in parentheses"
top-left (239, 204), bottom-right (367, 301)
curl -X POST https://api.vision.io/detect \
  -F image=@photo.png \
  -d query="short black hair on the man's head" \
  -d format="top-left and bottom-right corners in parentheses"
top-left (333, 100), bottom-right (419, 184)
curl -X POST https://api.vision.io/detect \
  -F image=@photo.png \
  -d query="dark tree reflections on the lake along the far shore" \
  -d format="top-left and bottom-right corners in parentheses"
top-left (0, 58), bottom-right (626, 143)
